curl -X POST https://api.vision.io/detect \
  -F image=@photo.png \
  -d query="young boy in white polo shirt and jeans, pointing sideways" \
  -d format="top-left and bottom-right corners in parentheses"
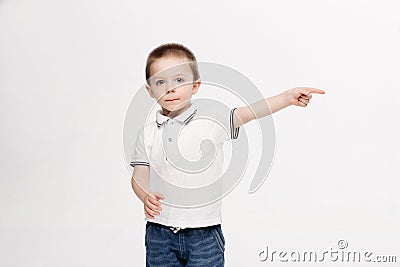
top-left (130, 43), bottom-right (325, 266)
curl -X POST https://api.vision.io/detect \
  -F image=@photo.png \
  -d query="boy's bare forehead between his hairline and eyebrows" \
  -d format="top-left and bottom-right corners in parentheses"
top-left (150, 57), bottom-right (192, 77)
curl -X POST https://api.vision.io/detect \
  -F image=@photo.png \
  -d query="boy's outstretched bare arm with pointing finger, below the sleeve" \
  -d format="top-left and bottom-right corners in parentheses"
top-left (233, 87), bottom-right (325, 128)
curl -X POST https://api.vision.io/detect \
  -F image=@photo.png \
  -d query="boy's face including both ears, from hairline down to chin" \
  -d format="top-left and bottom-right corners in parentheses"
top-left (146, 56), bottom-right (200, 115)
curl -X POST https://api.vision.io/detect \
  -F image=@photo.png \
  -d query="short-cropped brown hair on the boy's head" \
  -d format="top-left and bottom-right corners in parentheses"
top-left (146, 43), bottom-right (200, 82)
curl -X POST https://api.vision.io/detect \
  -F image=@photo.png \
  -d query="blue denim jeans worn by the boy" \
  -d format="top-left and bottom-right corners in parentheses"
top-left (145, 222), bottom-right (225, 267)
